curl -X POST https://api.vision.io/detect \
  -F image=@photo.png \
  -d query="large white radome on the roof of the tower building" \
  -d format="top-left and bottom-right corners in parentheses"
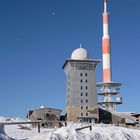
top-left (71, 48), bottom-right (89, 60)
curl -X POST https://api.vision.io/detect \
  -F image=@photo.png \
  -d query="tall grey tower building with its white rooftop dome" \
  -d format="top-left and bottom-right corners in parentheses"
top-left (63, 47), bottom-right (100, 122)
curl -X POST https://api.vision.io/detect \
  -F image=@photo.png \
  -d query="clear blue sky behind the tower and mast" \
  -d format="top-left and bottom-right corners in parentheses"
top-left (0, 0), bottom-right (140, 117)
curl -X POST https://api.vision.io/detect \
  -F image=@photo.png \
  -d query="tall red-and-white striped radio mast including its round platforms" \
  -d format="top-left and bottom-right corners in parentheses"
top-left (97, 0), bottom-right (122, 111)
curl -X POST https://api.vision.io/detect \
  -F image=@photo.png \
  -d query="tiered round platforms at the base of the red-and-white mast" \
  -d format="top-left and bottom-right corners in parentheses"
top-left (97, 81), bottom-right (122, 112)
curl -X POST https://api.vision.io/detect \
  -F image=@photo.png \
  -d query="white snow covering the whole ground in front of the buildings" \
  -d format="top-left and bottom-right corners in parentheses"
top-left (0, 117), bottom-right (140, 140)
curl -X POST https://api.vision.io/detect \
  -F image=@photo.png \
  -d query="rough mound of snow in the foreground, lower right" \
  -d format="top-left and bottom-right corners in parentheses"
top-left (30, 126), bottom-right (140, 140)
